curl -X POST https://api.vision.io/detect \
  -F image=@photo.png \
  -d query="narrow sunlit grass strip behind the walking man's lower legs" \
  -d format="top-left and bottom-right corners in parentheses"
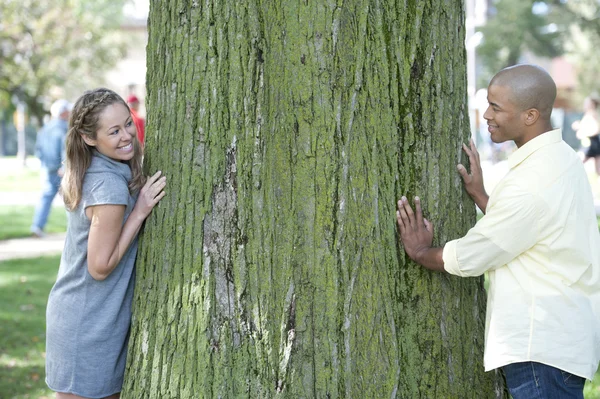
top-left (0, 205), bottom-right (67, 240)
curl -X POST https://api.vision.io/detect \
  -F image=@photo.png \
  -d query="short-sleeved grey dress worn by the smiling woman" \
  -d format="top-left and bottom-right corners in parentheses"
top-left (46, 152), bottom-right (137, 398)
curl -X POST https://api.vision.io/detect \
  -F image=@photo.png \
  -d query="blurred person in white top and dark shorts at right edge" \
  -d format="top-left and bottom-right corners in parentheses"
top-left (571, 96), bottom-right (600, 175)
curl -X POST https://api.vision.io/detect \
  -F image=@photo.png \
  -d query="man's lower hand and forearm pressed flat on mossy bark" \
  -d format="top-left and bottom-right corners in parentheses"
top-left (396, 197), bottom-right (444, 272)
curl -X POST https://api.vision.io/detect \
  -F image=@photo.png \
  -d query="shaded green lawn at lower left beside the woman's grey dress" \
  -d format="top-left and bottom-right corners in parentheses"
top-left (0, 256), bottom-right (60, 399)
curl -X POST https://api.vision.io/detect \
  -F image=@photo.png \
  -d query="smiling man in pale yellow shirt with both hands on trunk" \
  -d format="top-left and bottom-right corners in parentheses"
top-left (396, 65), bottom-right (600, 399)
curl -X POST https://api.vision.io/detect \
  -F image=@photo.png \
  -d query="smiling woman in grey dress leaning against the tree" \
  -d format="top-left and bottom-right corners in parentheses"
top-left (46, 89), bottom-right (166, 399)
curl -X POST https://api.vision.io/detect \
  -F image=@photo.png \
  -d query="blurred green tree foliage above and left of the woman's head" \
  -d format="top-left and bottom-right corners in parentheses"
top-left (0, 0), bottom-right (125, 119)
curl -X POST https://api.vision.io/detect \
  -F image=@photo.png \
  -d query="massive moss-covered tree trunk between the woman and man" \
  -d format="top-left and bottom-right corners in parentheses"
top-left (123, 0), bottom-right (503, 399)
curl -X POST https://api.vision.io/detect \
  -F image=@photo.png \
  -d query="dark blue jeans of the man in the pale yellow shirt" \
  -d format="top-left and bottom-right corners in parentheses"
top-left (502, 362), bottom-right (585, 399)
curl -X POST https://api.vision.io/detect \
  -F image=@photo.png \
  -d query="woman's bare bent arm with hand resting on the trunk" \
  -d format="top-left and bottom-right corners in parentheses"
top-left (86, 172), bottom-right (166, 280)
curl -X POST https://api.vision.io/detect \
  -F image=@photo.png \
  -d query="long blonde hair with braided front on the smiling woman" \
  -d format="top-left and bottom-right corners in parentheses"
top-left (61, 88), bottom-right (145, 211)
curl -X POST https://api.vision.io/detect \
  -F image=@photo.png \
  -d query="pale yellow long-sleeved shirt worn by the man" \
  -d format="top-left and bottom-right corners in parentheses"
top-left (443, 129), bottom-right (600, 379)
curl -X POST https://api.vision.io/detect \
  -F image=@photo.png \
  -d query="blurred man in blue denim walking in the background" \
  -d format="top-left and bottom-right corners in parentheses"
top-left (31, 99), bottom-right (72, 237)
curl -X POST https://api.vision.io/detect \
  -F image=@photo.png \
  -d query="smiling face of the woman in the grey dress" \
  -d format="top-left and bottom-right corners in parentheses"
top-left (84, 103), bottom-right (137, 161)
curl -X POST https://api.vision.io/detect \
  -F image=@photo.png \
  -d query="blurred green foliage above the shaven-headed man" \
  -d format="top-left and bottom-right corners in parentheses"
top-left (477, 0), bottom-right (600, 102)
